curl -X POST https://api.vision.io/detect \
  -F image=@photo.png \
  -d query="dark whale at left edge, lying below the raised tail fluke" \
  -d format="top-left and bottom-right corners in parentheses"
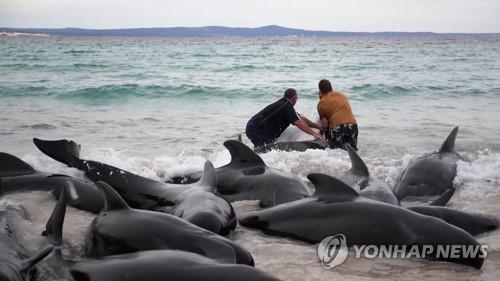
top-left (0, 152), bottom-right (103, 213)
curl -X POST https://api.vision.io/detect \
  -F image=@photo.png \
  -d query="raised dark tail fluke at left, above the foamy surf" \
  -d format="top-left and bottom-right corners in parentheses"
top-left (33, 138), bottom-right (80, 168)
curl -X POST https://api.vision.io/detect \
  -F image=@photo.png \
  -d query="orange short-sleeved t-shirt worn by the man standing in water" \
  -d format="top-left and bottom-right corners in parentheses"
top-left (318, 91), bottom-right (356, 128)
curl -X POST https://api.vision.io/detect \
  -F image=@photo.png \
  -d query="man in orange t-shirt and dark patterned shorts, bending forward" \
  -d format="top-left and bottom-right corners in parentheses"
top-left (318, 79), bottom-right (358, 150)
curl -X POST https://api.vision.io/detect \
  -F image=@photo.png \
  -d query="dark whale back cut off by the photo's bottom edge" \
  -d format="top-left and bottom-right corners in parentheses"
top-left (65, 250), bottom-right (278, 281)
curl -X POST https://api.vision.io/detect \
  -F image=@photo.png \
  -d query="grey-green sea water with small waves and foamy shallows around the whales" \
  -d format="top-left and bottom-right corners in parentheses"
top-left (0, 35), bottom-right (500, 280)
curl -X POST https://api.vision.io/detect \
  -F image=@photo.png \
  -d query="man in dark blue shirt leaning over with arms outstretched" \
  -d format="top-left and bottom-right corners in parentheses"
top-left (246, 89), bottom-right (324, 148)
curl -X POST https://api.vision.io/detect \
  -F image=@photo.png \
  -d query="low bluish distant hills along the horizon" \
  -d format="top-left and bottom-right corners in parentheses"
top-left (0, 25), bottom-right (494, 37)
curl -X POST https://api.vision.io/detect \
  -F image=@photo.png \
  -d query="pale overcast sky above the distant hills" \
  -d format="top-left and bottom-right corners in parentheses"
top-left (0, 0), bottom-right (500, 32)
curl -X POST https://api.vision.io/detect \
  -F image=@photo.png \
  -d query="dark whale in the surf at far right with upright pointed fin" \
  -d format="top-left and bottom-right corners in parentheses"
top-left (394, 127), bottom-right (461, 200)
